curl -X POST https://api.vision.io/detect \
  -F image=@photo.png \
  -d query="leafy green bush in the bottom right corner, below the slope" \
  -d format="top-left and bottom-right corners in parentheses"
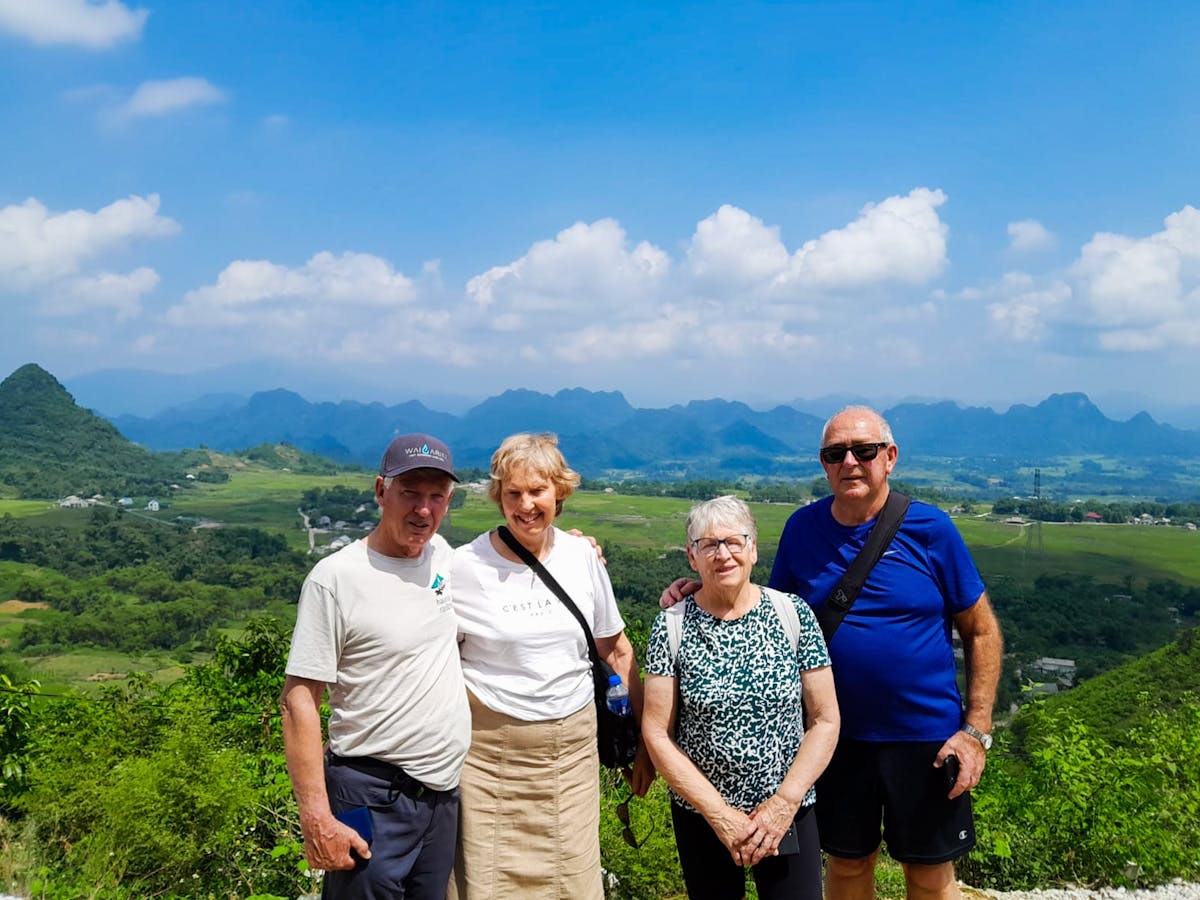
top-left (960, 695), bottom-right (1200, 889)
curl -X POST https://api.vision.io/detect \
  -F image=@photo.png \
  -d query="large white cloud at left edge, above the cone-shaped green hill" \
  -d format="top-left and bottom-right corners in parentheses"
top-left (0, 194), bottom-right (179, 287)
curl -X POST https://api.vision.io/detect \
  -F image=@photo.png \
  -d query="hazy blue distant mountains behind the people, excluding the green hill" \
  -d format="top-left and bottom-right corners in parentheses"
top-left (105, 388), bottom-right (1200, 489)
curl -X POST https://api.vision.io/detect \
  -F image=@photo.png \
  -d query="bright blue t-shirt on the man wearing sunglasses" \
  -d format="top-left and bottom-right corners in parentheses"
top-left (770, 497), bottom-right (984, 740)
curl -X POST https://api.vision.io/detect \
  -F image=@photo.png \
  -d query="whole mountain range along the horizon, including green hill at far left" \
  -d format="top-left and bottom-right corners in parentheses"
top-left (9, 365), bottom-right (1200, 498)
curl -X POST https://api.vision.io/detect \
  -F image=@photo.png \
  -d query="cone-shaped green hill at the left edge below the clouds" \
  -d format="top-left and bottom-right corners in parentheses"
top-left (0, 364), bottom-right (199, 498)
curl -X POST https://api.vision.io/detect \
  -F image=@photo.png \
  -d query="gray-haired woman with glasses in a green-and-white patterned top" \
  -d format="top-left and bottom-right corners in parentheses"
top-left (642, 497), bottom-right (840, 900)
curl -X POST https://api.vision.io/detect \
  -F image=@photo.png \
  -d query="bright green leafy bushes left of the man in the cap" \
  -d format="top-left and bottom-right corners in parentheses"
top-left (7, 620), bottom-right (311, 899)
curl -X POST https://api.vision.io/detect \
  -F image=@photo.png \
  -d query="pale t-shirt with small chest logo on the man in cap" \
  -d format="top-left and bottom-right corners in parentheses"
top-left (287, 535), bottom-right (470, 791)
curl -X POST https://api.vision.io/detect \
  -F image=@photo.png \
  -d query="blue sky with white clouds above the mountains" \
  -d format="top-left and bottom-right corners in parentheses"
top-left (0, 0), bottom-right (1200, 420)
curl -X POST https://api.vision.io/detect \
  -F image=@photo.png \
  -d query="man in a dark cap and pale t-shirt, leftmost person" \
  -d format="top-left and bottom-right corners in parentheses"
top-left (280, 434), bottom-right (470, 900)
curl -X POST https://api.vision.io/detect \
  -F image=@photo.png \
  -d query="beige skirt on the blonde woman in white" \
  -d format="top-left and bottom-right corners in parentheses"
top-left (446, 692), bottom-right (604, 900)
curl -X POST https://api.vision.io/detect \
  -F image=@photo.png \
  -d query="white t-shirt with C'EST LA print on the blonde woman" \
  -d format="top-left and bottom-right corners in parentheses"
top-left (451, 528), bottom-right (625, 721)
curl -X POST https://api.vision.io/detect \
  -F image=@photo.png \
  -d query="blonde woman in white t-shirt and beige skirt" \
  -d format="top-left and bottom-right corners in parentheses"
top-left (449, 434), bottom-right (654, 900)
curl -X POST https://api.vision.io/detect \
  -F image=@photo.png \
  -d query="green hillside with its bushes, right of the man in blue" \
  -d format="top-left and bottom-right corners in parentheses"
top-left (958, 629), bottom-right (1200, 890)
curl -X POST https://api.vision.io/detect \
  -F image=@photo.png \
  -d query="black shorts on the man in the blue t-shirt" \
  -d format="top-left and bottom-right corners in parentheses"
top-left (817, 738), bottom-right (976, 865)
